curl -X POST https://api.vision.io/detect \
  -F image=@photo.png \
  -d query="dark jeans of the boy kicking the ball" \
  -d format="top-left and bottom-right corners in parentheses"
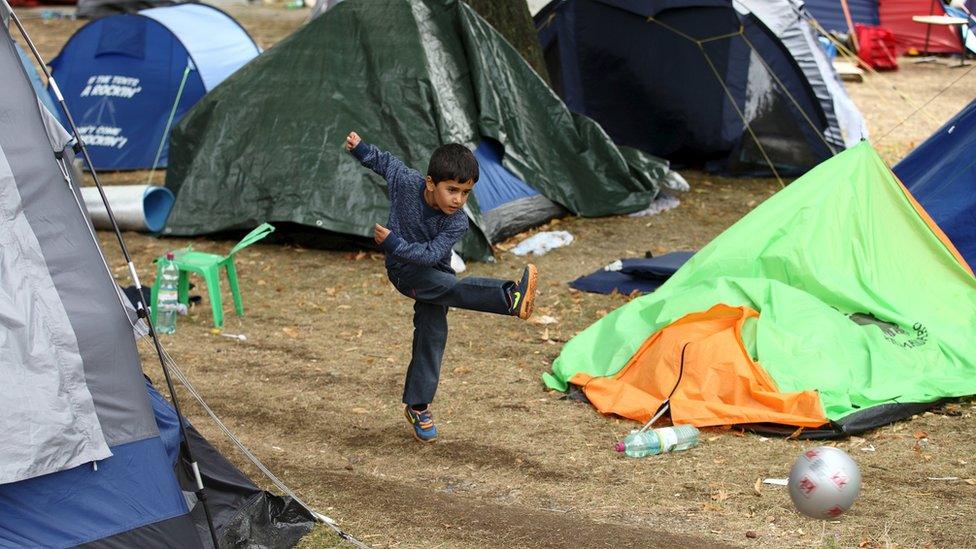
top-left (387, 263), bottom-right (515, 405)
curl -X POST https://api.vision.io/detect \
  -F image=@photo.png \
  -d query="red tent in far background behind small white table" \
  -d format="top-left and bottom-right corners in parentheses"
top-left (878, 0), bottom-right (962, 55)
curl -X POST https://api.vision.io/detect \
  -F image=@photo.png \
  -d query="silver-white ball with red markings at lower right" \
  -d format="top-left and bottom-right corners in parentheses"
top-left (789, 446), bottom-right (861, 520)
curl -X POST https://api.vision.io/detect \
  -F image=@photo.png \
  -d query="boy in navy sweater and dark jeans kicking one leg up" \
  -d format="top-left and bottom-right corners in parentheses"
top-left (346, 132), bottom-right (538, 442)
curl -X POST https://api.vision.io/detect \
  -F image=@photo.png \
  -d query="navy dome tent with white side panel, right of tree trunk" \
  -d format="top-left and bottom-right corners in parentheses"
top-left (535, 0), bottom-right (866, 173)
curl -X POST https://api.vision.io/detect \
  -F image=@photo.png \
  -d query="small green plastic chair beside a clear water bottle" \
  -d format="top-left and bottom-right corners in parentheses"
top-left (151, 223), bottom-right (274, 328)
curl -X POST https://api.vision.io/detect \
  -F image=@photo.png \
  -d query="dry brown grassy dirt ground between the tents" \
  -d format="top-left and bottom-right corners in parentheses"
top-left (13, 5), bottom-right (976, 547)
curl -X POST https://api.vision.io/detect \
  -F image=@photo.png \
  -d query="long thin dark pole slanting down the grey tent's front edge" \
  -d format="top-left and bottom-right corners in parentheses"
top-left (0, 0), bottom-right (220, 549)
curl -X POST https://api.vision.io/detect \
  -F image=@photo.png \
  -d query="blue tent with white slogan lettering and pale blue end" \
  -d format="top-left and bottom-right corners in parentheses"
top-left (51, 4), bottom-right (260, 170)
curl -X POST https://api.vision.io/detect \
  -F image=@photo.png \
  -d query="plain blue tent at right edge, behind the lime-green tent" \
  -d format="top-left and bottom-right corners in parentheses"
top-left (893, 100), bottom-right (976, 269)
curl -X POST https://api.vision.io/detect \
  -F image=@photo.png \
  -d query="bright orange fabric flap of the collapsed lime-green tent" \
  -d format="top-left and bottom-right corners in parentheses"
top-left (570, 304), bottom-right (827, 427)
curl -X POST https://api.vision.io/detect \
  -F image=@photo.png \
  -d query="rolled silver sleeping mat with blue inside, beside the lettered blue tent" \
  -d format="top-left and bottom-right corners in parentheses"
top-left (81, 185), bottom-right (176, 233)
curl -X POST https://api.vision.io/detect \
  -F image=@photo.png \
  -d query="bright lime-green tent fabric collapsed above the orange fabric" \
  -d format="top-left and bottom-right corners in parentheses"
top-left (544, 142), bottom-right (976, 426)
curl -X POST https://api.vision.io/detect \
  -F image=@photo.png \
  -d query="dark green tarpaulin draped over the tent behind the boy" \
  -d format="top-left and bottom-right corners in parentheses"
top-left (165, 0), bottom-right (669, 258)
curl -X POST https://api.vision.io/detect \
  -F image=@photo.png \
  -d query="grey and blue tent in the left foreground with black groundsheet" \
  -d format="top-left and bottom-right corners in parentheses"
top-left (0, 7), bottom-right (312, 548)
